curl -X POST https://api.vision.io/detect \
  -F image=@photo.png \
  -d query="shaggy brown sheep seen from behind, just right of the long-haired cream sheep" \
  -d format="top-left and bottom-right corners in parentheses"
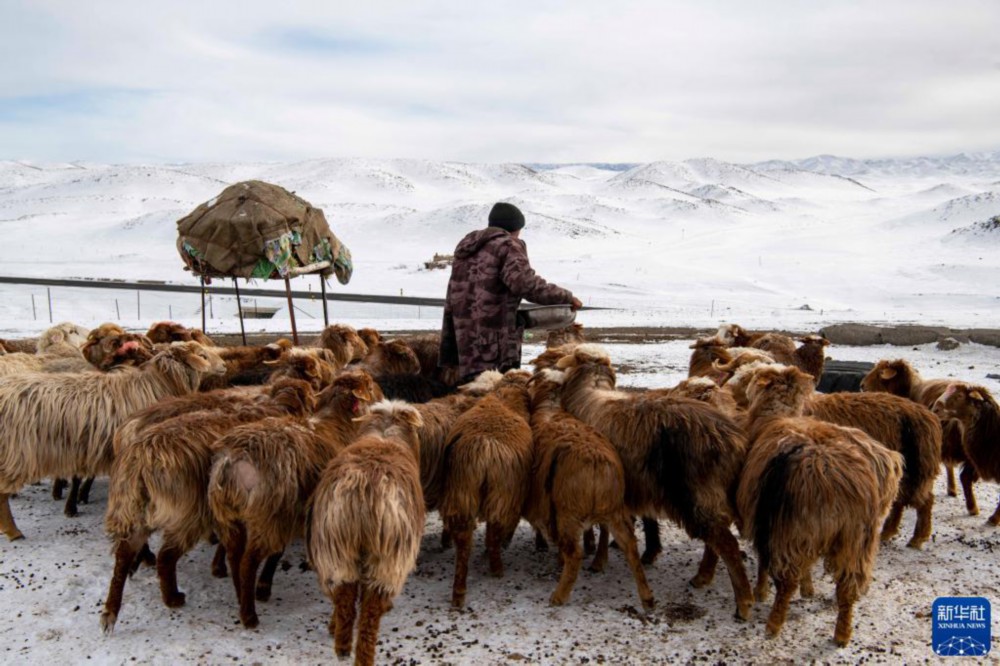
top-left (101, 380), bottom-right (313, 633)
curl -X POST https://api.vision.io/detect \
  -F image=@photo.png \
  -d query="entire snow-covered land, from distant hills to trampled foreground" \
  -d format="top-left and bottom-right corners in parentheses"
top-left (0, 153), bottom-right (1000, 664)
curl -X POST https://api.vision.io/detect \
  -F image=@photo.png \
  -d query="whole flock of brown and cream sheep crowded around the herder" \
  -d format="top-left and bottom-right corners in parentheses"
top-left (0, 322), bottom-right (1000, 664)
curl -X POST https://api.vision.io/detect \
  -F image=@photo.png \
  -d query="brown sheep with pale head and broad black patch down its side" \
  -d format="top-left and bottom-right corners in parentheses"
top-left (559, 345), bottom-right (753, 620)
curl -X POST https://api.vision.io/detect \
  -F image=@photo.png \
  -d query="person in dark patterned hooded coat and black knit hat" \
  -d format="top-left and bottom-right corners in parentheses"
top-left (438, 202), bottom-right (583, 383)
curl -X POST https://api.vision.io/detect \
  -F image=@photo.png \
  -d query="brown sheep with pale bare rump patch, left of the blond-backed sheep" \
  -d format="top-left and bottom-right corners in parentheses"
top-left (208, 370), bottom-right (374, 629)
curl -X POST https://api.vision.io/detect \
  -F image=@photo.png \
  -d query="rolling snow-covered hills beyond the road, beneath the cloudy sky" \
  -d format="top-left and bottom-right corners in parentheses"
top-left (0, 152), bottom-right (1000, 338)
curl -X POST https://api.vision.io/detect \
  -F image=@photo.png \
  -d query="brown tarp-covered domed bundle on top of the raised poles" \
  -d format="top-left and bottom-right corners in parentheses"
top-left (177, 180), bottom-right (353, 284)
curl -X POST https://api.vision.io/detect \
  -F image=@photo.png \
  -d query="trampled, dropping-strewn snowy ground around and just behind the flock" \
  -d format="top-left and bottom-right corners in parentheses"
top-left (0, 341), bottom-right (1000, 664)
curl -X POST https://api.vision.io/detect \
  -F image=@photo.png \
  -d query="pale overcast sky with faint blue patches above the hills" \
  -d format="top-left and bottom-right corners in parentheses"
top-left (0, 0), bottom-right (1000, 162)
